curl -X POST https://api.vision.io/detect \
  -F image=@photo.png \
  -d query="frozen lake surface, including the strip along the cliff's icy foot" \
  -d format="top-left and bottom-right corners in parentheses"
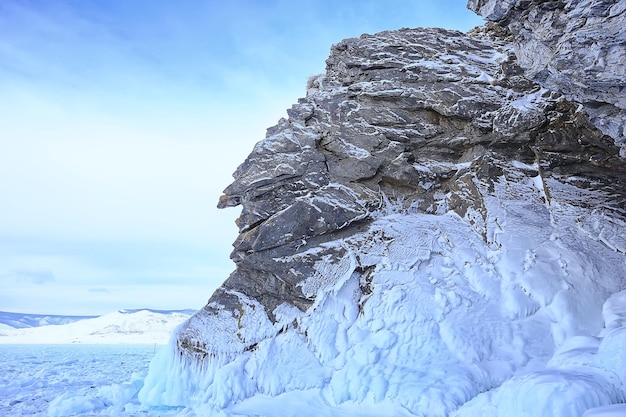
top-left (0, 345), bottom-right (626, 417)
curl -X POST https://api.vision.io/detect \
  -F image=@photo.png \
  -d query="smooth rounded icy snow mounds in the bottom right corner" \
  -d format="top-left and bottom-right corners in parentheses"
top-left (453, 291), bottom-right (626, 417)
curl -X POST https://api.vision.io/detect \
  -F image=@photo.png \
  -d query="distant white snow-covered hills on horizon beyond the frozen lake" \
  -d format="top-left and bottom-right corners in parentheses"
top-left (0, 309), bottom-right (194, 344)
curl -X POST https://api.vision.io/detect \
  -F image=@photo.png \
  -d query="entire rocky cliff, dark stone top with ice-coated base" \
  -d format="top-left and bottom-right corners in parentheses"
top-left (140, 0), bottom-right (626, 416)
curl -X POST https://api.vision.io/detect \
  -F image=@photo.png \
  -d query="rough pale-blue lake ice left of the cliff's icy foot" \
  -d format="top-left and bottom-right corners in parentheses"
top-left (0, 345), bottom-right (177, 417)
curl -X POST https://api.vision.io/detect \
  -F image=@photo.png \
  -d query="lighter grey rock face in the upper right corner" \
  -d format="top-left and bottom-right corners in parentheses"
top-left (468, 0), bottom-right (626, 157)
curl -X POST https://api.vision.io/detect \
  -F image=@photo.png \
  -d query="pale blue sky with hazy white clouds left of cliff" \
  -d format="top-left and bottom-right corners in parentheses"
top-left (0, 0), bottom-right (482, 315)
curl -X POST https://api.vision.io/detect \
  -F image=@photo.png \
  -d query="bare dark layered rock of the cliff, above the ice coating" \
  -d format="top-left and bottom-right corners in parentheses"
top-left (181, 23), bottom-right (626, 358)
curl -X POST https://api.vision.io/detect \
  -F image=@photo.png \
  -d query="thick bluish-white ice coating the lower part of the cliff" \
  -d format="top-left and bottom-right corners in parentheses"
top-left (139, 193), bottom-right (626, 416)
